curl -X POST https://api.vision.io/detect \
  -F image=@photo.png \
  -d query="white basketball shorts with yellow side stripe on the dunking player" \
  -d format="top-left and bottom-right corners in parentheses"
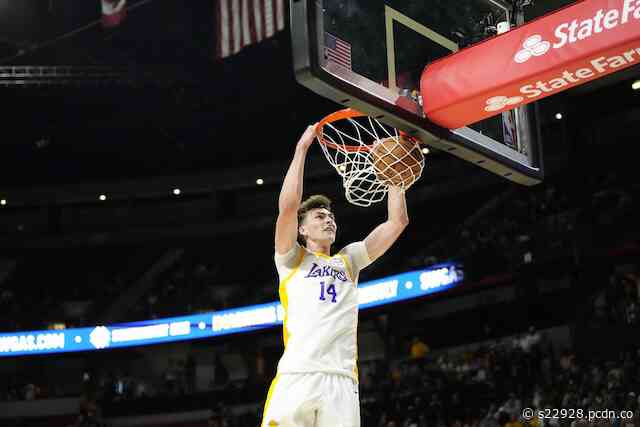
top-left (261, 372), bottom-right (360, 427)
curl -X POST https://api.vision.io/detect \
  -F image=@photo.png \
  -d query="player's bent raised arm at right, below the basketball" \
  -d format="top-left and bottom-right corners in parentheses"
top-left (364, 186), bottom-right (409, 262)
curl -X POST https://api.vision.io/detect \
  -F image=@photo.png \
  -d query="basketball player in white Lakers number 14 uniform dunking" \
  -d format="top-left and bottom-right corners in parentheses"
top-left (261, 126), bottom-right (409, 427)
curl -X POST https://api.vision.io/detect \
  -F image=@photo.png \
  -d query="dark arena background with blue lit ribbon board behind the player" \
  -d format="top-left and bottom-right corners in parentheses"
top-left (0, 0), bottom-right (640, 427)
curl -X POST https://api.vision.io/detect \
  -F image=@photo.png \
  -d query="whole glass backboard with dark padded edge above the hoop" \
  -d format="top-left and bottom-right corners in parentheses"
top-left (291, 0), bottom-right (543, 185)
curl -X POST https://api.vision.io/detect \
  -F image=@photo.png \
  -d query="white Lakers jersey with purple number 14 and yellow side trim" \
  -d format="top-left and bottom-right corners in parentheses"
top-left (275, 242), bottom-right (371, 381)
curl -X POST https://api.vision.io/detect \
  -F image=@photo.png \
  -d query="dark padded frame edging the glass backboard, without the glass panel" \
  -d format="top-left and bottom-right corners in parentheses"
top-left (290, 0), bottom-right (544, 185)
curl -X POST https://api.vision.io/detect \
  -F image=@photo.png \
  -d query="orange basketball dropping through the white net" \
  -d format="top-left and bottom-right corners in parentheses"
top-left (371, 137), bottom-right (424, 190)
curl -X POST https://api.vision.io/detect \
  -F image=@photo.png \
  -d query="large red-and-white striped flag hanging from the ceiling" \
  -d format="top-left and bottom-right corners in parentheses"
top-left (214, 0), bottom-right (285, 58)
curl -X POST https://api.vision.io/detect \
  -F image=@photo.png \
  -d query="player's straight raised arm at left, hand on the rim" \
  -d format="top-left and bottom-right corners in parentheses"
top-left (275, 125), bottom-right (316, 254)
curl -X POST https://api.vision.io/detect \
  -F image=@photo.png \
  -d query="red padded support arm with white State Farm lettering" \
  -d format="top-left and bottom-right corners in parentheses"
top-left (420, 0), bottom-right (640, 129)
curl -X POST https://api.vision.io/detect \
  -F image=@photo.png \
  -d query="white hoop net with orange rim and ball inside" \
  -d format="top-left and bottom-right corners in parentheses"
top-left (318, 110), bottom-right (424, 207)
